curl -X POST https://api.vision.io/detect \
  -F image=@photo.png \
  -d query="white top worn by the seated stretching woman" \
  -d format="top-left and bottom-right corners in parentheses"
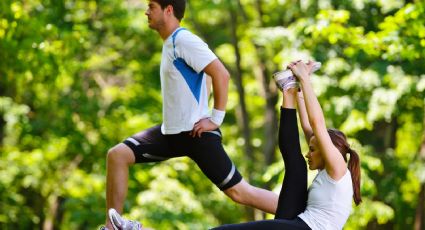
top-left (298, 169), bottom-right (353, 230)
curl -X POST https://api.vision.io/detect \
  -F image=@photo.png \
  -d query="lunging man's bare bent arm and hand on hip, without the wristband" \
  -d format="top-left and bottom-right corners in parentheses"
top-left (192, 59), bottom-right (230, 137)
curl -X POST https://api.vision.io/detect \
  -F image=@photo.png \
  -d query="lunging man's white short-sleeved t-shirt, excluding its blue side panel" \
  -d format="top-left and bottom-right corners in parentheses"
top-left (160, 29), bottom-right (217, 134)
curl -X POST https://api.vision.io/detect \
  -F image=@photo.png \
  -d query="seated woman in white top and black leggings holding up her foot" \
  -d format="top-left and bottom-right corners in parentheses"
top-left (210, 61), bottom-right (361, 230)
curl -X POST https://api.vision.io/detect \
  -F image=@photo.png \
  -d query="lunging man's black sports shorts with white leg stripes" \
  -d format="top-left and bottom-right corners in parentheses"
top-left (124, 125), bottom-right (242, 190)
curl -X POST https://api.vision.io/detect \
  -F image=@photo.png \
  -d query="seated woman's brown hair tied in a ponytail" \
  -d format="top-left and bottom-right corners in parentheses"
top-left (328, 129), bottom-right (362, 205)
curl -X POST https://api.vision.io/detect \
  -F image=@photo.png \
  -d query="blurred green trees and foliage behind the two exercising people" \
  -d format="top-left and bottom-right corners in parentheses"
top-left (0, 0), bottom-right (425, 230)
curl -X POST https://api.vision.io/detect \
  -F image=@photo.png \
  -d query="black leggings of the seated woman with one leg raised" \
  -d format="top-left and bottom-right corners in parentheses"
top-left (214, 108), bottom-right (310, 230)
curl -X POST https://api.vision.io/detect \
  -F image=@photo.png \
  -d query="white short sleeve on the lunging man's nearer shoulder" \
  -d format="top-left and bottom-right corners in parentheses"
top-left (175, 31), bottom-right (217, 73)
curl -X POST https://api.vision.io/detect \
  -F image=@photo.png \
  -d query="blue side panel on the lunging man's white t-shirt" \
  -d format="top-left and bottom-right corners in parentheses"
top-left (173, 58), bottom-right (204, 103)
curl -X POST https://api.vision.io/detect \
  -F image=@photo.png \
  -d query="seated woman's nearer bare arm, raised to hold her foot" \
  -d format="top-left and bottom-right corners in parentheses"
top-left (289, 62), bottom-right (347, 180)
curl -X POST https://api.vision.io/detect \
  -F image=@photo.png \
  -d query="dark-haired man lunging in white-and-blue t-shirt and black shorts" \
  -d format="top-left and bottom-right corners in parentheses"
top-left (101, 0), bottom-right (278, 229)
